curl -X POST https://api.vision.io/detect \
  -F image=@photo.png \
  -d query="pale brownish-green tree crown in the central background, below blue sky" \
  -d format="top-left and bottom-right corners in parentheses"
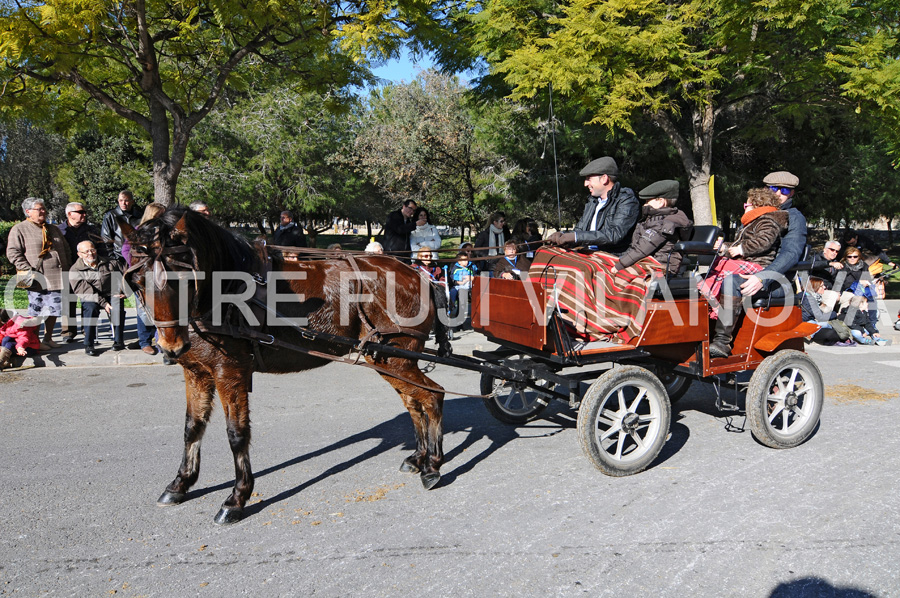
top-left (353, 71), bottom-right (519, 226)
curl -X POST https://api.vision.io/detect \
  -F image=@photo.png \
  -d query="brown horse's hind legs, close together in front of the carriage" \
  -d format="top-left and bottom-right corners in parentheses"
top-left (379, 358), bottom-right (444, 490)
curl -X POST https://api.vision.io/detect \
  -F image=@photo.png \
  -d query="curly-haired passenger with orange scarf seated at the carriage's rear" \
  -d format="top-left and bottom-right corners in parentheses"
top-left (698, 187), bottom-right (788, 357)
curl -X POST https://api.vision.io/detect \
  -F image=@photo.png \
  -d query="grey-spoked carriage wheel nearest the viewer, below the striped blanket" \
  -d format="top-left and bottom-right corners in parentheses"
top-left (578, 365), bottom-right (672, 477)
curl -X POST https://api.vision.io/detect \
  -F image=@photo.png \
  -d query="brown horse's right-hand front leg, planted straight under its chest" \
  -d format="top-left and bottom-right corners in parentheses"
top-left (215, 368), bottom-right (253, 524)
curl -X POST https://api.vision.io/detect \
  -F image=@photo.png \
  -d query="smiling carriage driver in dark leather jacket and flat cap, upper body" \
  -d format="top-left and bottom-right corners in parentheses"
top-left (548, 156), bottom-right (641, 255)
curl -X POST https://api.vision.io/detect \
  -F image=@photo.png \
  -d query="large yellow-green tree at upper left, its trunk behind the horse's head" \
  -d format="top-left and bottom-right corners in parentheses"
top-left (0, 0), bottom-right (444, 204)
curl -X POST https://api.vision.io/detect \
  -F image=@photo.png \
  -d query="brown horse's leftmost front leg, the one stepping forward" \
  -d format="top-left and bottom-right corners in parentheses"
top-left (156, 368), bottom-right (215, 507)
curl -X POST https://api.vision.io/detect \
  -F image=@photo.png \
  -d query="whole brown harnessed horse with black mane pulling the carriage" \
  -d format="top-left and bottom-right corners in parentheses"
top-left (123, 208), bottom-right (446, 523)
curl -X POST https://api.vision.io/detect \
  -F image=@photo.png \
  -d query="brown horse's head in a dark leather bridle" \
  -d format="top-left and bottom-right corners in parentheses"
top-left (120, 208), bottom-right (203, 358)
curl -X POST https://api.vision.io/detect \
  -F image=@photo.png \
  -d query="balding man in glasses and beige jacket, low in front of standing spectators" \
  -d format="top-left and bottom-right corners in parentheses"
top-left (70, 241), bottom-right (125, 357)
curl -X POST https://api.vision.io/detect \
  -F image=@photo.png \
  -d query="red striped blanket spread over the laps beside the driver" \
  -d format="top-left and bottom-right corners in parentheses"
top-left (528, 247), bottom-right (665, 343)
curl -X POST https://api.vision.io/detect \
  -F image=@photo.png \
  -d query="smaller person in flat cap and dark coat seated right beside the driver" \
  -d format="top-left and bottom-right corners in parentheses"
top-left (616, 180), bottom-right (693, 274)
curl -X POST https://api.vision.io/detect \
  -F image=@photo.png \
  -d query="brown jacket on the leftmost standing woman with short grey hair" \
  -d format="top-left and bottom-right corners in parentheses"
top-left (6, 220), bottom-right (72, 291)
